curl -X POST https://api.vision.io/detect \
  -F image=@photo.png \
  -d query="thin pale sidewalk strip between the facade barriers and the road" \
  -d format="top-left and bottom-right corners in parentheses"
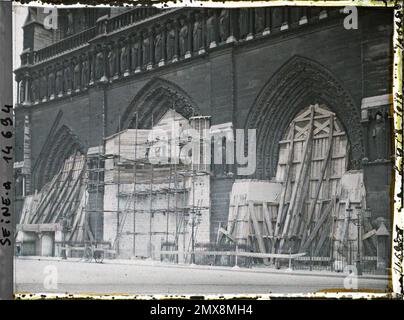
top-left (15, 256), bottom-right (389, 280)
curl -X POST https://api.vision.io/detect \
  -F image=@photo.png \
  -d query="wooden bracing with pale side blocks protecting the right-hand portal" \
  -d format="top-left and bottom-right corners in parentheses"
top-left (218, 105), bottom-right (375, 263)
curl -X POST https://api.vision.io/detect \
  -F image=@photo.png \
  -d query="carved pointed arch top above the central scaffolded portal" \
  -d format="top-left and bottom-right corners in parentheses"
top-left (117, 78), bottom-right (201, 131)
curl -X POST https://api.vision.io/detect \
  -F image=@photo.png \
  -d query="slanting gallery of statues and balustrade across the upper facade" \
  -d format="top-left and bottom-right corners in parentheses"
top-left (16, 7), bottom-right (340, 105)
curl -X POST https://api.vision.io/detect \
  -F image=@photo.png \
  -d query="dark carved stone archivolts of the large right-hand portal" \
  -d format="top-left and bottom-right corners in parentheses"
top-left (245, 56), bottom-right (363, 179)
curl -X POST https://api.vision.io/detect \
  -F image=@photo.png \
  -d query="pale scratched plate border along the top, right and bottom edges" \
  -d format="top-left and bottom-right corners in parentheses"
top-left (0, 0), bottom-right (404, 300)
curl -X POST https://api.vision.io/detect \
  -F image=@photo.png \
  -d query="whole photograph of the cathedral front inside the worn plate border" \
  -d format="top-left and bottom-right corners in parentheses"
top-left (5, 4), bottom-right (395, 296)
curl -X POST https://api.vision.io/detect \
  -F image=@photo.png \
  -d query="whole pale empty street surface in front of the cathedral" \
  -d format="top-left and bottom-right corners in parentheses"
top-left (15, 257), bottom-right (389, 295)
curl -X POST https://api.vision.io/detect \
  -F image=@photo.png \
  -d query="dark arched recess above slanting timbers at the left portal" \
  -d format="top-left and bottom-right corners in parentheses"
top-left (34, 125), bottom-right (85, 190)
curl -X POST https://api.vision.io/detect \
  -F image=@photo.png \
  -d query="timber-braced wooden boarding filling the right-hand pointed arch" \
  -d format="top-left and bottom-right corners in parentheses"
top-left (273, 105), bottom-right (349, 256)
